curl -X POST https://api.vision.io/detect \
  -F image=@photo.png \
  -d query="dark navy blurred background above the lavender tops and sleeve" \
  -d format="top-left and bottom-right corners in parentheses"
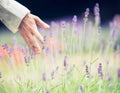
top-left (0, 0), bottom-right (120, 31)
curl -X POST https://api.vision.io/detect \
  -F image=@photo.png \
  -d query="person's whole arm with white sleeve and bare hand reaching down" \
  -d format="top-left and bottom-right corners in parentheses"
top-left (0, 0), bottom-right (49, 54)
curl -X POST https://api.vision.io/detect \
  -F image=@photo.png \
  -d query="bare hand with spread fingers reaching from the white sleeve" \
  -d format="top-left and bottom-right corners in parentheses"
top-left (19, 13), bottom-right (49, 54)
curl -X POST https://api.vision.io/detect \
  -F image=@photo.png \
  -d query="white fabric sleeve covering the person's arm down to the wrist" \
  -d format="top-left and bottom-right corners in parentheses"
top-left (0, 0), bottom-right (30, 33)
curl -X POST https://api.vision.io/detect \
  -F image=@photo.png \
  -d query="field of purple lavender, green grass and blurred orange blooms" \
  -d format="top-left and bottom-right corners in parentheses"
top-left (0, 4), bottom-right (120, 93)
